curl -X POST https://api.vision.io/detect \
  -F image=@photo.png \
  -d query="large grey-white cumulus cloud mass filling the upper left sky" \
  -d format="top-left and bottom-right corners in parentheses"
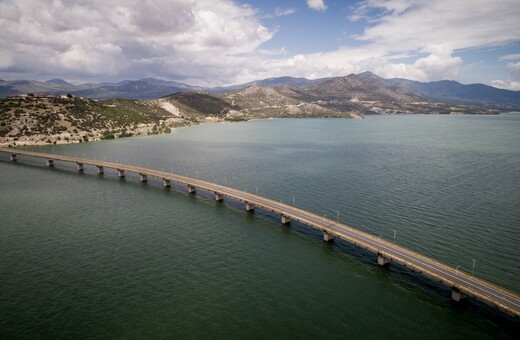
top-left (0, 0), bottom-right (274, 84)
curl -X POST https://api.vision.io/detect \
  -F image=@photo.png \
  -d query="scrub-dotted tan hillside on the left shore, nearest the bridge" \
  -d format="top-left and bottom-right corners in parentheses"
top-left (0, 97), bottom-right (189, 146)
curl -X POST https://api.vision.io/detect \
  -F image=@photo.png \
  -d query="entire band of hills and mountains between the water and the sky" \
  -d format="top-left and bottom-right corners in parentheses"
top-left (0, 73), bottom-right (520, 146)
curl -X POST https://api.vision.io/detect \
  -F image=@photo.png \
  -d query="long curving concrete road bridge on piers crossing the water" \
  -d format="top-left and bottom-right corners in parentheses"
top-left (0, 148), bottom-right (520, 317)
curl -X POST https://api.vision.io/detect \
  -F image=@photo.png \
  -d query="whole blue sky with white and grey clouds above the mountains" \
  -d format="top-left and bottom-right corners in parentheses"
top-left (0, 0), bottom-right (520, 90)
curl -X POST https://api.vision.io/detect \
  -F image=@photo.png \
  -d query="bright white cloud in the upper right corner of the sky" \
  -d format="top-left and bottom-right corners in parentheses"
top-left (358, 0), bottom-right (520, 50)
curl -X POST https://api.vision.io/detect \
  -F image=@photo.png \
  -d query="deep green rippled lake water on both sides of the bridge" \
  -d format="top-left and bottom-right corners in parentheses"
top-left (0, 114), bottom-right (520, 339)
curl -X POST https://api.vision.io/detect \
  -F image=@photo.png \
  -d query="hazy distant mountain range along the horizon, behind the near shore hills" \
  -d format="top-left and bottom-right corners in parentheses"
top-left (0, 72), bottom-right (520, 109)
